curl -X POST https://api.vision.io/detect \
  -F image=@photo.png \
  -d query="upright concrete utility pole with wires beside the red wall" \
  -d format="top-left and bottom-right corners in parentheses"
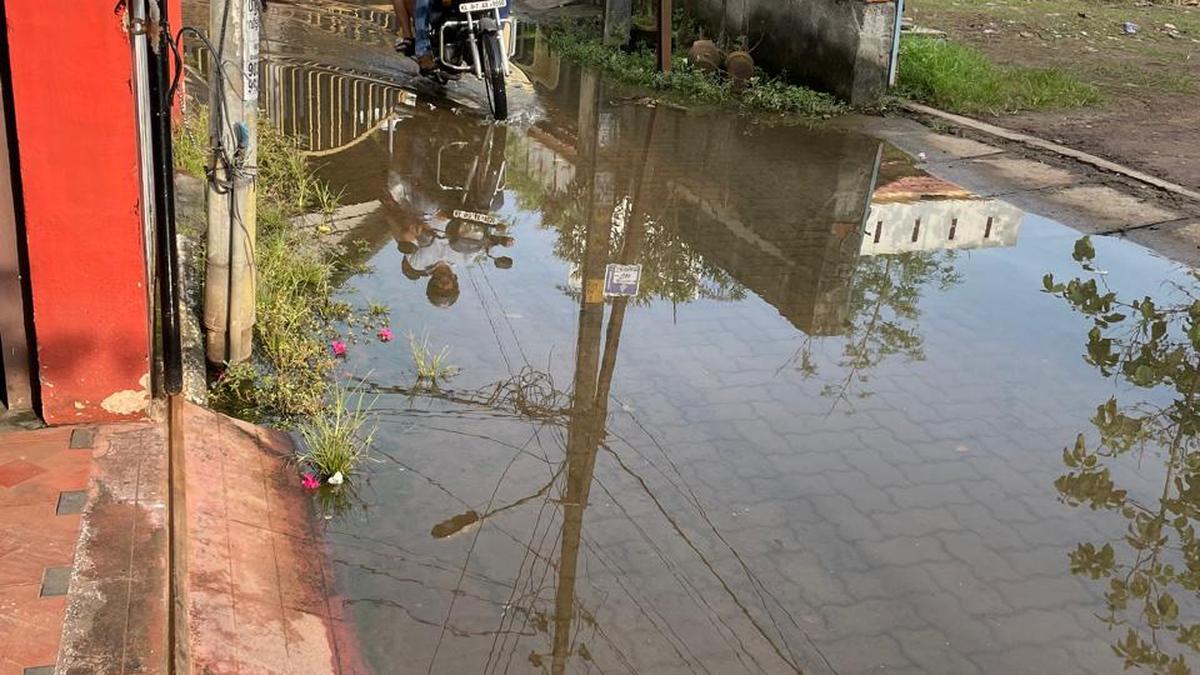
top-left (204, 0), bottom-right (263, 364)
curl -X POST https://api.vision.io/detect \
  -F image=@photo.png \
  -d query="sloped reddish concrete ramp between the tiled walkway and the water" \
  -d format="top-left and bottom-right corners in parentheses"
top-left (185, 406), bottom-right (366, 675)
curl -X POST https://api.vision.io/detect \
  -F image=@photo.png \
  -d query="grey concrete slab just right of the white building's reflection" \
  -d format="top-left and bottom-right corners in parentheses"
top-left (1032, 185), bottom-right (1183, 233)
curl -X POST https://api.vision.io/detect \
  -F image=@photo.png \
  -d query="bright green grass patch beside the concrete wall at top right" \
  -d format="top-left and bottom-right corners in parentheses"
top-left (900, 37), bottom-right (1100, 115)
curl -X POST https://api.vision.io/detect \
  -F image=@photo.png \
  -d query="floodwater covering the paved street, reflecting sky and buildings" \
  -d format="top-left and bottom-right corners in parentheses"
top-left (189, 5), bottom-right (1200, 675)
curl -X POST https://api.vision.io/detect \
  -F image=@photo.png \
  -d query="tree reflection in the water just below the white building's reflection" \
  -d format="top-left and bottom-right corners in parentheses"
top-left (790, 251), bottom-right (961, 401)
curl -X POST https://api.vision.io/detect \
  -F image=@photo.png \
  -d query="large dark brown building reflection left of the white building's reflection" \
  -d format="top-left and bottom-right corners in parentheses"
top-left (517, 42), bottom-right (880, 335)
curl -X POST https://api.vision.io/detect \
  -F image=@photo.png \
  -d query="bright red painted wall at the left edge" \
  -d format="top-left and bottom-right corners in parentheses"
top-left (4, 0), bottom-right (150, 424)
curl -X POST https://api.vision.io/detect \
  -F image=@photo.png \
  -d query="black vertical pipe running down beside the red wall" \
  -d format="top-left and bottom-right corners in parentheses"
top-left (146, 0), bottom-right (184, 395)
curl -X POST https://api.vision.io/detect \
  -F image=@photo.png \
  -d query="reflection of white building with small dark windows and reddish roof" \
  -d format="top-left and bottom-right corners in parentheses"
top-left (862, 175), bottom-right (1024, 256)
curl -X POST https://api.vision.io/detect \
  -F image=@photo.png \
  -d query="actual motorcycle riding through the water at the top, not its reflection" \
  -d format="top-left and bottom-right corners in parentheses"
top-left (430, 0), bottom-right (515, 120)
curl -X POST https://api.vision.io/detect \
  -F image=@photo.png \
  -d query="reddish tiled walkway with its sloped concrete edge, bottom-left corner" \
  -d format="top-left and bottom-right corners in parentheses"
top-left (0, 406), bottom-right (366, 675)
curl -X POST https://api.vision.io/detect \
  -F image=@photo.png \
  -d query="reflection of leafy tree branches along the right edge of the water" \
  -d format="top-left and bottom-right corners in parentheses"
top-left (1044, 238), bottom-right (1200, 675)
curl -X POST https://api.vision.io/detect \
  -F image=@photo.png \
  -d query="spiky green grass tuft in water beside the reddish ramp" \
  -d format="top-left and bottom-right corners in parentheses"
top-left (296, 386), bottom-right (374, 488)
